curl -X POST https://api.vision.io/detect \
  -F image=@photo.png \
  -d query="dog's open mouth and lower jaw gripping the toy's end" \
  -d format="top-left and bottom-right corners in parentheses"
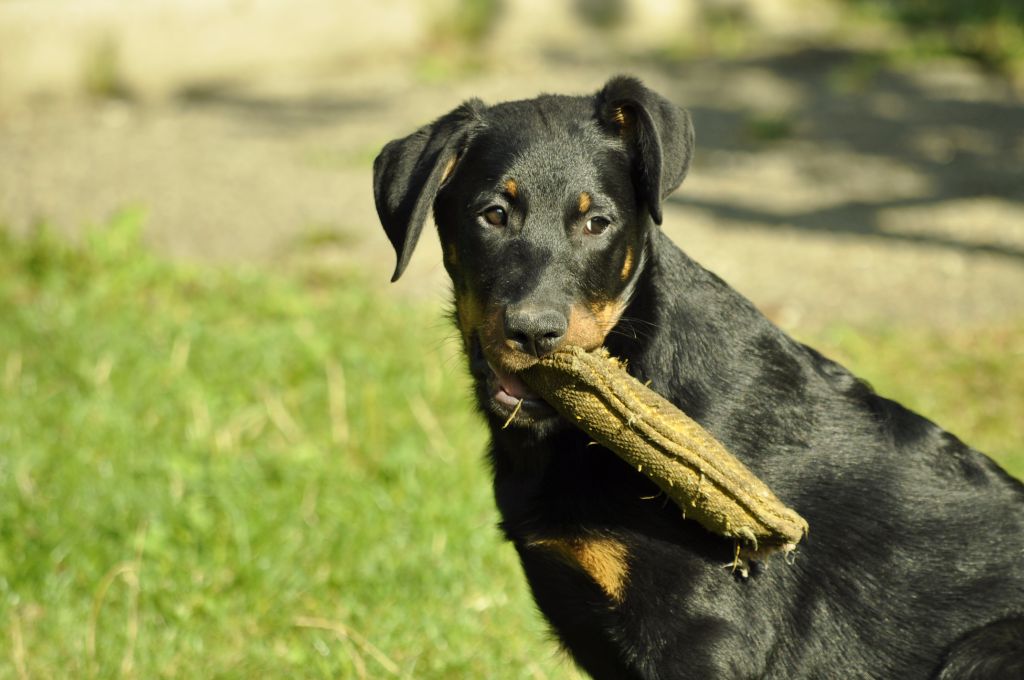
top-left (470, 337), bottom-right (558, 426)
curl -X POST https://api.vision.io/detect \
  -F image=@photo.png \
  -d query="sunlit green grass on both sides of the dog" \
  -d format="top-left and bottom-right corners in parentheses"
top-left (0, 213), bottom-right (1024, 678)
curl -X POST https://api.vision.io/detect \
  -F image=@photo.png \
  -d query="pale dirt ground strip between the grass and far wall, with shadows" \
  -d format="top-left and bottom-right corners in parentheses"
top-left (0, 15), bottom-right (1024, 328)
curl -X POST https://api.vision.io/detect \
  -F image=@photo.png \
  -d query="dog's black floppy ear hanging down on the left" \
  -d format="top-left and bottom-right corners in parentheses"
top-left (374, 99), bottom-right (483, 281)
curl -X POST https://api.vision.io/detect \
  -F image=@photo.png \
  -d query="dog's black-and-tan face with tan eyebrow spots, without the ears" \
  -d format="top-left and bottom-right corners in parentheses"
top-left (434, 100), bottom-right (648, 423)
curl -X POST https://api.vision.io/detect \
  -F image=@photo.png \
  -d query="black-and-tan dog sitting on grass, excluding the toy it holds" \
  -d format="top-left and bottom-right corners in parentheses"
top-left (374, 78), bottom-right (1024, 680)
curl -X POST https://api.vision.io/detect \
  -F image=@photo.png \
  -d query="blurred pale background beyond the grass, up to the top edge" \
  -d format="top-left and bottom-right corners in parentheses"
top-left (0, 0), bottom-right (1024, 325)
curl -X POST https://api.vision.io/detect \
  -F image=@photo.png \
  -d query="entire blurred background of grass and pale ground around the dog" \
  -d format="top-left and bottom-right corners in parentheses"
top-left (0, 0), bottom-right (1024, 678)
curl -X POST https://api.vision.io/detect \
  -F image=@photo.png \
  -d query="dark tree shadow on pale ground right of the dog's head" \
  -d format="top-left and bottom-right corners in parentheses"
top-left (638, 49), bottom-right (1024, 260)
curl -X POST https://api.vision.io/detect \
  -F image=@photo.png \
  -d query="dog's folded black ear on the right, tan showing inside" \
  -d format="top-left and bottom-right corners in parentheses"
top-left (596, 76), bottom-right (693, 224)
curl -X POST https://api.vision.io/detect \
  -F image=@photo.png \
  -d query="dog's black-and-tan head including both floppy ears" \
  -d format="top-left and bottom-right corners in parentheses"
top-left (374, 77), bottom-right (693, 424)
